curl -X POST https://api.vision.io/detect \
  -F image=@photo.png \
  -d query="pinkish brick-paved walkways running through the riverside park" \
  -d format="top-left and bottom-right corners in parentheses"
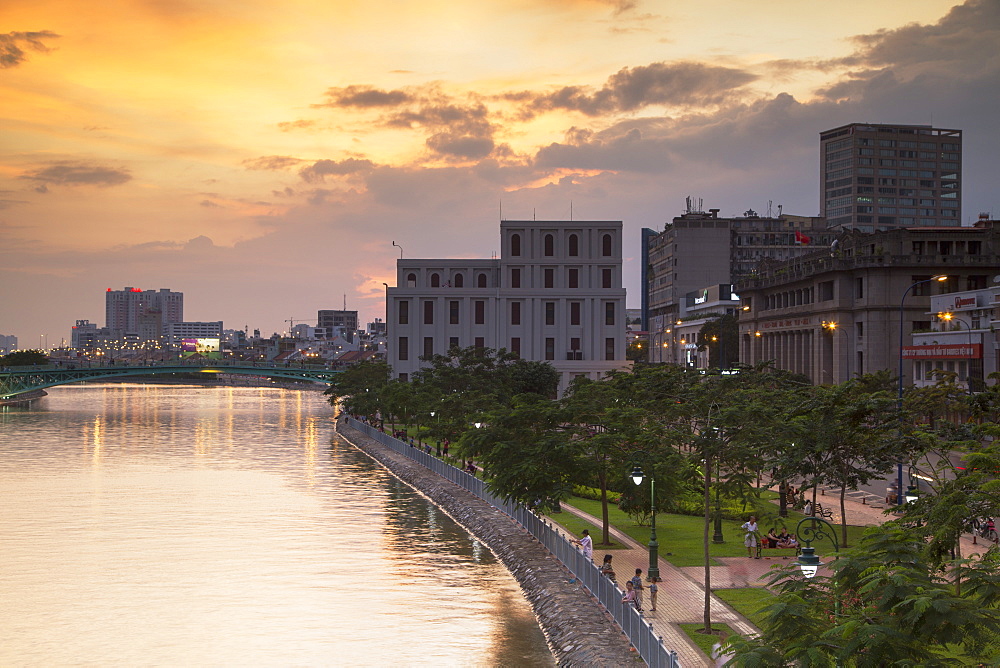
top-left (550, 482), bottom-right (989, 668)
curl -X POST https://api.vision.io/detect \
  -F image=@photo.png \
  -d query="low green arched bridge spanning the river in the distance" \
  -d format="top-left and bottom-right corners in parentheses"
top-left (0, 360), bottom-right (341, 401)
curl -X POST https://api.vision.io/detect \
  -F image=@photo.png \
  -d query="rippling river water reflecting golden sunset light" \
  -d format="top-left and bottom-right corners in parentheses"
top-left (0, 385), bottom-right (554, 666)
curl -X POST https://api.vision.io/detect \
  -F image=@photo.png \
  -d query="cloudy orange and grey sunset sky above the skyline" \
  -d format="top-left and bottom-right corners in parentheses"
top-left (0, 0), bottom-right (1000, 347)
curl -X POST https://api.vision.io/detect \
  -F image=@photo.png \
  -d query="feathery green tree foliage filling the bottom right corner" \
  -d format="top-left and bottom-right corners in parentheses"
top-left (729, 521), bottom-right (1000, 668)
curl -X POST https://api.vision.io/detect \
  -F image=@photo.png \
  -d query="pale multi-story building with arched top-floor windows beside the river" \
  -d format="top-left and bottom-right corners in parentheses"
top-left (386, 220), bottom-right (629, 393)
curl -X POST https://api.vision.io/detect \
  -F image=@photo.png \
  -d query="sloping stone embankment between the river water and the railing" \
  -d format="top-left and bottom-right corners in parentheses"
top-left (337, 419), bottom-right (641, 666)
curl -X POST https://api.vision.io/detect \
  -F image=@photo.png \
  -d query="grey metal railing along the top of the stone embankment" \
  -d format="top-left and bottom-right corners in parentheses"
top-left (347, 417), bottom-right (680, 668)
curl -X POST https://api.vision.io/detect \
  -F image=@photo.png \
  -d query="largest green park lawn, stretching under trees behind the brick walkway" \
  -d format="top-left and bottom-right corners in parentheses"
top-left (553, 496), bottom-right (876, 566)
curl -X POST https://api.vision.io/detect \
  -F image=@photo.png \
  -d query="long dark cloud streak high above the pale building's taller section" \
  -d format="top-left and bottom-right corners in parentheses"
top-left (520, 63), bottom-right (757, 116)
